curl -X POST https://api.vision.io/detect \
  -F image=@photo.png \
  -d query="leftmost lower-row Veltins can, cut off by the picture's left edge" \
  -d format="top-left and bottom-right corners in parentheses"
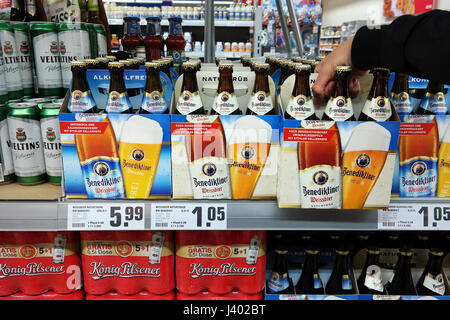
top-left (0, 106), bottom-right (15, 184)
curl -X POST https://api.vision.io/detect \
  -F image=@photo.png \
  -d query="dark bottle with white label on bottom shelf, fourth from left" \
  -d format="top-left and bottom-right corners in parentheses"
top-left (357, 246), bottom-right (385, 294)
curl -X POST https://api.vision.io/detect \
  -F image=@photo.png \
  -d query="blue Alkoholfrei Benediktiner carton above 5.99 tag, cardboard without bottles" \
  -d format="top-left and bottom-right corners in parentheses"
top-left (59, 68), bottom-right (172, 199)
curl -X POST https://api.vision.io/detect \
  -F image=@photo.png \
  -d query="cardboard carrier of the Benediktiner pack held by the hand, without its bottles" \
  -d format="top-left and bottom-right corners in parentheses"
top-left (277, 73), bottom-right (400, 209)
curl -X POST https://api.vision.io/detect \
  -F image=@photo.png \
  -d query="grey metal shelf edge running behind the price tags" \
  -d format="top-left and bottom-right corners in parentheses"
top-left (0, 198), bottom-right (450, 231)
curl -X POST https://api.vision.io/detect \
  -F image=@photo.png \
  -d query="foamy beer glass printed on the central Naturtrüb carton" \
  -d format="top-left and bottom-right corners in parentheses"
top-left (228, 116), bottom-right (272, 199)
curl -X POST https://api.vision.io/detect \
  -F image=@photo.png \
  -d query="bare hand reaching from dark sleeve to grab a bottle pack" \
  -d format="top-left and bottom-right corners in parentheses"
top-left (312, 37), bottom-right (367, 104)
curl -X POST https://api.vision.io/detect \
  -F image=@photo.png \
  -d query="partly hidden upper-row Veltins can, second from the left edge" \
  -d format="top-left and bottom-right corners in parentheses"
top-left (11, 22), bottom-right (34, 96)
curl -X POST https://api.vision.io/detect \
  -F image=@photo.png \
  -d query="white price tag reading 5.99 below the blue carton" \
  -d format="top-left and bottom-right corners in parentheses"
top-left (67, 203), bottom-right (145, 231)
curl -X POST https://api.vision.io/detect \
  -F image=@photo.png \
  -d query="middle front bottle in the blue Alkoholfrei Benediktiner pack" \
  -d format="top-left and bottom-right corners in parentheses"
top-left (106, 62), bottom-right (133, 113)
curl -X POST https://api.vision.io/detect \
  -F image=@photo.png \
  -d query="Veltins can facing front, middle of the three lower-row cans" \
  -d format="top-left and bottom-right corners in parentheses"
top-left (7, 102), bottom-right (46, 185)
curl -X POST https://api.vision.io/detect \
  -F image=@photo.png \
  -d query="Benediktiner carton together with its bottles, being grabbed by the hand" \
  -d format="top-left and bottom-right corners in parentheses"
top-left (277, 63), bottom-right (400, 209)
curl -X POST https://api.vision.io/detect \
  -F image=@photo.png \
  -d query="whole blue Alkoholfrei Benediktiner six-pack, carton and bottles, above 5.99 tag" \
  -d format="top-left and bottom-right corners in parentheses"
top-left (59, 58), bottom-right (172, 199)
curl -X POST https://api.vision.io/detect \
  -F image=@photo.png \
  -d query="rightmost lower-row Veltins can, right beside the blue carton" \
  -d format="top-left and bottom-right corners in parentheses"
top-left (41, 103), bottom-right (62, 184)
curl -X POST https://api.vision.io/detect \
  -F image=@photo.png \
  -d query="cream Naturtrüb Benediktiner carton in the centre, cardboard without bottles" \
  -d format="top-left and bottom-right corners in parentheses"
top-left (171, 64), bottom-right (279, 199)
